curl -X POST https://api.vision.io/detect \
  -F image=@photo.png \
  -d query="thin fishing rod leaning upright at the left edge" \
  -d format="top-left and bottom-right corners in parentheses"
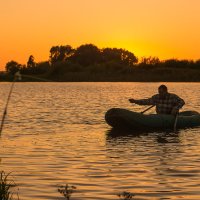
top-left (0, 71), bottom-right (21, 135)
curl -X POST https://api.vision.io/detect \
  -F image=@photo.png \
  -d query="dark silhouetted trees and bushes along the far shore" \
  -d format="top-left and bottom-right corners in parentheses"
top-left (0, 44), bottom-right (200, 82)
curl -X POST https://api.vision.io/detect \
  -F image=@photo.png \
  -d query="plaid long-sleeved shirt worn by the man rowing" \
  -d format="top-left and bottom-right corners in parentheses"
top-left (135, 93), bottom-right (185, 114)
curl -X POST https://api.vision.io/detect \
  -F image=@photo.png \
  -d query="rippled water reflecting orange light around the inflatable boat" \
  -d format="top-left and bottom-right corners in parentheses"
top-left (0, 83), bottom-right (200, 200)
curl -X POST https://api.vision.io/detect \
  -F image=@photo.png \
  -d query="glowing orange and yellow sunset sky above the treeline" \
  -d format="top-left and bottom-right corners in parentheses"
top-left (0, 0), bottom-right (200, 70)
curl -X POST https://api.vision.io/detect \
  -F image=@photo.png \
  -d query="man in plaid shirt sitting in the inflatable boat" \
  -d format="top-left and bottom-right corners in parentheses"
top-left (129, 85), bottom-right (185, 115)
